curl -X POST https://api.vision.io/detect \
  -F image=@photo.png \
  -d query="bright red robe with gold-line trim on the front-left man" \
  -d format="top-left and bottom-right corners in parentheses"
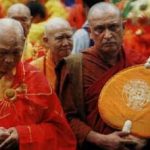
top-left (0, 63), bottom-right (76, 150)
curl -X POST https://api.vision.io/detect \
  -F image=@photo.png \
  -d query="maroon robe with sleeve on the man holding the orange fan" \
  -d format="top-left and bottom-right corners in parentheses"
top-left (58, 48), bottom-right (129, 150)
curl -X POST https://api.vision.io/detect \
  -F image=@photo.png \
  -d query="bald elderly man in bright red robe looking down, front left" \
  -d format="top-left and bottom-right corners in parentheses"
top-left (0, 18), bottom-right (76, 150)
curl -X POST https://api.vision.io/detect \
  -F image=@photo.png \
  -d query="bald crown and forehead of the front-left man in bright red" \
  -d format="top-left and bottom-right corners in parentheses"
top-left (0, 18), bottom-right (24, 44)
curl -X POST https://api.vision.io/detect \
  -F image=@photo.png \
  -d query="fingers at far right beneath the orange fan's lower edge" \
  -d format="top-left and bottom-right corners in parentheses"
top-left (126, 135), bottom-right (147, 150)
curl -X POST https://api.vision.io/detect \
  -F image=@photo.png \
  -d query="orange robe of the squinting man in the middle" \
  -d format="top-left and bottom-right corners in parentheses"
top-left (31, 52), bottom-right (56, 89)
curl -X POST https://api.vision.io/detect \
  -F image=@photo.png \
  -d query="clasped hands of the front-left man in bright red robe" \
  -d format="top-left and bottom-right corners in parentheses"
top-left (0, 128), bottom-right (19, 150)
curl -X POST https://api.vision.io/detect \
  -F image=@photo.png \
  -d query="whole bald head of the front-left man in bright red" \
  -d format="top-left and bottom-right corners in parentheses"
top-left (0, 18), bottom-right (25, 78)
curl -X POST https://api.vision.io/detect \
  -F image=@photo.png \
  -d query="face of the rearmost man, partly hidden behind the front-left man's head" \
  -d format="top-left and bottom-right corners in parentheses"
top-left (8, 9), bottom-right (32, 37)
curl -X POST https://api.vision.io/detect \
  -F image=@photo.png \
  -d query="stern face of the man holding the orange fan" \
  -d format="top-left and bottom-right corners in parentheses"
top-left (90, 12), bottom-right (123, 55)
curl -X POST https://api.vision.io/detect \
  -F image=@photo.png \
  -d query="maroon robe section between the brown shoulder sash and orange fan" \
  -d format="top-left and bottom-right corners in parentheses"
top-left (83, 48), bottom-right (130, 134)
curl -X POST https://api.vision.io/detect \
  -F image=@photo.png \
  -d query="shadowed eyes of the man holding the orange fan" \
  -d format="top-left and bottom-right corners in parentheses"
top-left (92, 23), bottom-right (121, 35)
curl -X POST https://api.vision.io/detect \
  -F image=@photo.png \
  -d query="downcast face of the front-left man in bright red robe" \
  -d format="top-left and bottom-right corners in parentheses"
top-left (0, 30), bottom-right (24, 75)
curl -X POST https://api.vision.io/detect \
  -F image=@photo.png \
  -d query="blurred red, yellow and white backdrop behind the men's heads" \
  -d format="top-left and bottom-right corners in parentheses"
top-left (0, 0), bottom-right (150, 63)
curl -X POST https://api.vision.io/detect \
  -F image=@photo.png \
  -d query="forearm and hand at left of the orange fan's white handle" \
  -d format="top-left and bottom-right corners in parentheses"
top-left (87, 131), bottom-right (137, 150)
